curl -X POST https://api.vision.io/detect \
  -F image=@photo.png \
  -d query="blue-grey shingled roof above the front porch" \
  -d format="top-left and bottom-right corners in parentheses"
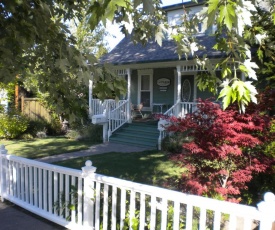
top-left (100, 36), bottom-right (225, 65)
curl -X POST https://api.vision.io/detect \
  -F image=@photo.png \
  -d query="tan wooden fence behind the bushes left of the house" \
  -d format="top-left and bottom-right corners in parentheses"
top-left (21, 97), bottom-right (51, 122)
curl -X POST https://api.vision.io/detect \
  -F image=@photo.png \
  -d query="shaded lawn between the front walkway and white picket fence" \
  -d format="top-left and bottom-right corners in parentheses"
top-left (54, 150), bottom-right (184, 189)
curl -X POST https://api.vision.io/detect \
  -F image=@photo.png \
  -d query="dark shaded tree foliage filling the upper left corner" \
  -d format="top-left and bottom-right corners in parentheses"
top-left (0, 0), bottom-right (124, 116)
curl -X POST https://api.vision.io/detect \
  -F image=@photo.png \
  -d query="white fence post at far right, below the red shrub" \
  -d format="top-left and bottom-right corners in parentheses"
top-left (257, 192), bottom-right (275, 230)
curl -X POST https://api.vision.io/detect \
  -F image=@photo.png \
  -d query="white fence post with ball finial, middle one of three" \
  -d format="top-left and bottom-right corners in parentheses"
top-left (82, 160), bottom-right (96, 229)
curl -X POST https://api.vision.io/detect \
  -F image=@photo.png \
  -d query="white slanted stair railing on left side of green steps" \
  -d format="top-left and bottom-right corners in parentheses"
top-left (108, 100), bottom-right (130, 141)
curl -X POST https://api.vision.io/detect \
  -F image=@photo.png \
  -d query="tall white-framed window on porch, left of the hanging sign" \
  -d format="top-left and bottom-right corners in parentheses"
top-left (138, 70), bottom-right (153, 111)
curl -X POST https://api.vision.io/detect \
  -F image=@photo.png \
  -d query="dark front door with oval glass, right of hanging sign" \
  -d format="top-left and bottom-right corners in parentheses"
top-left (181, 75), bottom-right (194, 102)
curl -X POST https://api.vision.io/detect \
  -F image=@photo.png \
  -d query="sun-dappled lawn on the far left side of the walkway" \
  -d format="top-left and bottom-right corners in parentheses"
top-left (0, 136), bottom-right (100, 159)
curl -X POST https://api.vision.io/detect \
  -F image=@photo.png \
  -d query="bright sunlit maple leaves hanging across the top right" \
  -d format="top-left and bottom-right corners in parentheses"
top-left (89, 0), bottom-right (275, 112)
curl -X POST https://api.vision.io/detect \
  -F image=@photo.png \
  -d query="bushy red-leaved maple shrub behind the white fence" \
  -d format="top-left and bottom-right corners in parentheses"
top-left (165, 90), bottom-right (274, 202)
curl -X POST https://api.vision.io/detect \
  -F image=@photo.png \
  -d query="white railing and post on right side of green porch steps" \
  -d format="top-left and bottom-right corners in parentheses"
top-left (158, 102), bottom-right (198, 150)
